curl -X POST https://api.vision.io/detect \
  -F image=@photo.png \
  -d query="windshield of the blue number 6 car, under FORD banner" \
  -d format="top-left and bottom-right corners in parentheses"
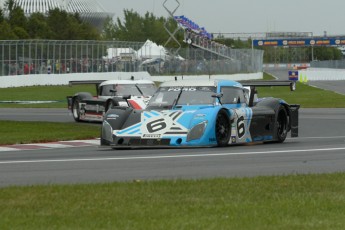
top-left (148, 87), bottom-right (216, 109)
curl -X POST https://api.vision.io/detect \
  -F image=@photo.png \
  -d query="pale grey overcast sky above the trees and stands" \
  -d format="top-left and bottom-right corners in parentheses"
top-left (98, 0), bottom-right (345, 36)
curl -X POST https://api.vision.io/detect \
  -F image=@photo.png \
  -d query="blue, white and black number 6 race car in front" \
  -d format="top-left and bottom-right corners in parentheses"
top-left (101, 80), bottom-right (299, 148)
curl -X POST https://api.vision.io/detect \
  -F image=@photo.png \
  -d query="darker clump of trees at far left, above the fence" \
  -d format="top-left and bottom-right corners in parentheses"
top-left (0, 0), bottom-right (100, 40)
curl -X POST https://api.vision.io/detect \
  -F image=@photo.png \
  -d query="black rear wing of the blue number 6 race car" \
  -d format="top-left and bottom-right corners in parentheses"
top-left (240, 81), bottom-right (296, 107)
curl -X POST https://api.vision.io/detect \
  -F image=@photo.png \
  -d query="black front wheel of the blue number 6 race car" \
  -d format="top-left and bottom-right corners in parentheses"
top-left (216, 110), bottom-right (231, 147)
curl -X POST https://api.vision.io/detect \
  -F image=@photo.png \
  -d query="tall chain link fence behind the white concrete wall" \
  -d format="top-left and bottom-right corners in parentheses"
top-left (0, 40), bottom-right (263, 76)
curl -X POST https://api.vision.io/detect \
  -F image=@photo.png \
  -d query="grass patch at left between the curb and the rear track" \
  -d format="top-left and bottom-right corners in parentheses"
top-left (0, 120), bottom-right (101, 145)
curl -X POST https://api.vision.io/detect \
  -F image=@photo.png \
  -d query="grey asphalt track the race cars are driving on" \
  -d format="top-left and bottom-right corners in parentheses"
top-left (0, 70), bottom-right (345, 187)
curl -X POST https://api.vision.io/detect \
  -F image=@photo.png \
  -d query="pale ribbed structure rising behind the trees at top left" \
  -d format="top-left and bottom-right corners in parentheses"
top-left (0, 0), bottom-right (114, 29)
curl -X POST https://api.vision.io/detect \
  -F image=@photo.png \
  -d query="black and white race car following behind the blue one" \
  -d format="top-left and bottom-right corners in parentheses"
top-left (67, 80), bottom-right (156, 122)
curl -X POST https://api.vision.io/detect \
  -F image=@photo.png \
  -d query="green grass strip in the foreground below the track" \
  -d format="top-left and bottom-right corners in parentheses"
top-left (0, 173), bottom-right (345, 230)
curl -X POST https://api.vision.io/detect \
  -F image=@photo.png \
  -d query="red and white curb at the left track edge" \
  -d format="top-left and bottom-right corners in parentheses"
top-left (0, 139), bottom-right (100, 152)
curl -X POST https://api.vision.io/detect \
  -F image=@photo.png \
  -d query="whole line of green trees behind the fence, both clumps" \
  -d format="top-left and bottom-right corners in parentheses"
top-left (0, 0), bottom-right (183, 47)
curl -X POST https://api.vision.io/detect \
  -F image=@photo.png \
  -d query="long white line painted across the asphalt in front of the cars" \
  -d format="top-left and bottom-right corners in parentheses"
top-left (0, 147), bottom-right (345, 164)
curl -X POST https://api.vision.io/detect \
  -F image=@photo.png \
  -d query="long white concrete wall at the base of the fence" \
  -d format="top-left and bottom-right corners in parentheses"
top-left (0, 72), bottom-right (263, 88)
